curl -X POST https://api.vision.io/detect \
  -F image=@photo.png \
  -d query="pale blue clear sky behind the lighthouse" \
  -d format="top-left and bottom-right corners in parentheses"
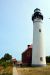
top-left (0, 0), bottom-right (50, 60)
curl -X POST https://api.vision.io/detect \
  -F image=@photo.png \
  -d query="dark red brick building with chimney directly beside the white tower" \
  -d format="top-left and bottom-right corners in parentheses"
top-left (22, 45), bottom-right (32, 66)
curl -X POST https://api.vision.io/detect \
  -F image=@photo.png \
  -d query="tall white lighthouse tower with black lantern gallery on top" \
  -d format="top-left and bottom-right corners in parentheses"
top-left (32, 8), bottom-right (46, 66)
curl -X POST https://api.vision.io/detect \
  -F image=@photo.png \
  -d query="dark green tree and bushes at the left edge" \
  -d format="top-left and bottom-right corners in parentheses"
top-left (0, 53), bottom-right (12, 68)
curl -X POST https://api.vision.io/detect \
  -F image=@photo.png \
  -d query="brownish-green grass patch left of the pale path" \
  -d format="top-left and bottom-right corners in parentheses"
top-left (0, 66), bottom-right (13, 75)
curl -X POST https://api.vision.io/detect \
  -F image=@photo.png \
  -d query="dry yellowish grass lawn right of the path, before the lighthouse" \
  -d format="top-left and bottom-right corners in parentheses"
top-left (17, 65), bottom-right (50, 75)
